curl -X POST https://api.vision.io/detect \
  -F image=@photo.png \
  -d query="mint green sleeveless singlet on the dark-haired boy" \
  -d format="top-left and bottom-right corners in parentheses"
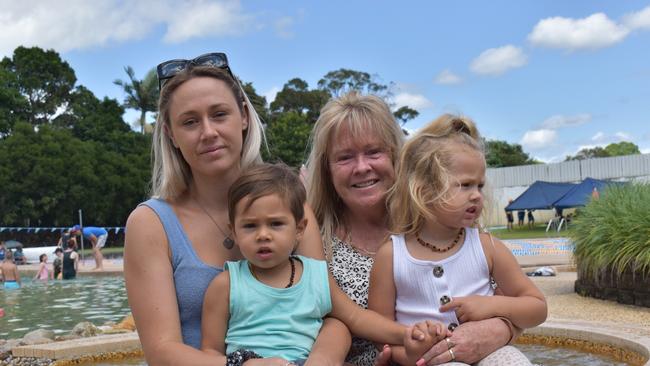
top-left (225, 256), bottom-right (332, 361)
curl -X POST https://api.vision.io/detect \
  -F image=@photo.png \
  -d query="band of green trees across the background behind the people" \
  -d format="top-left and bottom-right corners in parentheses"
top-left (0, 47), bottom-right (548, 232)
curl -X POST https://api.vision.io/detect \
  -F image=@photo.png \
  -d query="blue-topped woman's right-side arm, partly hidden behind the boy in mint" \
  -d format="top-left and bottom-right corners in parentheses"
top-left (296, 204), bottom-right (352, 366)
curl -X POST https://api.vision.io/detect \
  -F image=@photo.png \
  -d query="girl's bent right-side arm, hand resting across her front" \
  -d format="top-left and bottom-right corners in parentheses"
top-left (440, 234), bottom-right (547, 328)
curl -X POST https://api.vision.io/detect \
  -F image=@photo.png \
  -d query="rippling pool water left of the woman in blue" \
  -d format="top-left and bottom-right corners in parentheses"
top-left (0, 276), bottom-right (131, 338)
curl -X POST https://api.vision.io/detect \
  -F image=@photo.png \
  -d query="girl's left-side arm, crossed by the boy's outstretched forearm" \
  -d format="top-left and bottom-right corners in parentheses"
top-left (368, 242), bottom-right (447, 365)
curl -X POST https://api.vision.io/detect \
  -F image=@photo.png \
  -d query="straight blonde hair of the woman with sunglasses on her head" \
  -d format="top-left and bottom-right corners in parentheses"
top-left (151, 66), bottom-right (264, 200)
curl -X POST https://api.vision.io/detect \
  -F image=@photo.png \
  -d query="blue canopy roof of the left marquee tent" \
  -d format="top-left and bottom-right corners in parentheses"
top-left (506, 180), bottom-right (577, 211)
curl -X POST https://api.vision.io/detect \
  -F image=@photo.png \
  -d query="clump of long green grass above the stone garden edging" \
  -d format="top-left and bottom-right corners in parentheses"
top-left (569, 184), bottom-right (650, 277)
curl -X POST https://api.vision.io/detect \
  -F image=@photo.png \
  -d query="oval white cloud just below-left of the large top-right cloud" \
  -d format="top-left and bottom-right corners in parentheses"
top-left (470, 45), bottom-right (528, 75)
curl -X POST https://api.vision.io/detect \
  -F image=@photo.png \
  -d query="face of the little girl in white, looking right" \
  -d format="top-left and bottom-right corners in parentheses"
top-left (433, 144), bottom-right (485, 228)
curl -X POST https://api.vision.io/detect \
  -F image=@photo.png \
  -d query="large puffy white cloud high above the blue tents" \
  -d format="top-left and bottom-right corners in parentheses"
top-left (528, 13), bottom-right (629, 50)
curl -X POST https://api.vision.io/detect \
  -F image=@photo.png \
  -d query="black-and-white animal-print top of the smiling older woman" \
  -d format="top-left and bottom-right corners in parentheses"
top-left (328, 236), bottom-right (379, 366)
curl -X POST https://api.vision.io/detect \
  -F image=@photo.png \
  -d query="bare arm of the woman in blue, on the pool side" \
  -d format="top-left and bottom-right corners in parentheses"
top-left (124, 206), bottom-right (219, 366)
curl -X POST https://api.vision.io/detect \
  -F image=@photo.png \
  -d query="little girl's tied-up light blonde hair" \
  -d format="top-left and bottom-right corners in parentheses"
top-left (388, 114), bottom-right (485, 235)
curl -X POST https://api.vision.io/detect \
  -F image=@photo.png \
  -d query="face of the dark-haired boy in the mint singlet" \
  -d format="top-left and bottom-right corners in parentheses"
top-left (231, 194), bottom-right (307, 269)
